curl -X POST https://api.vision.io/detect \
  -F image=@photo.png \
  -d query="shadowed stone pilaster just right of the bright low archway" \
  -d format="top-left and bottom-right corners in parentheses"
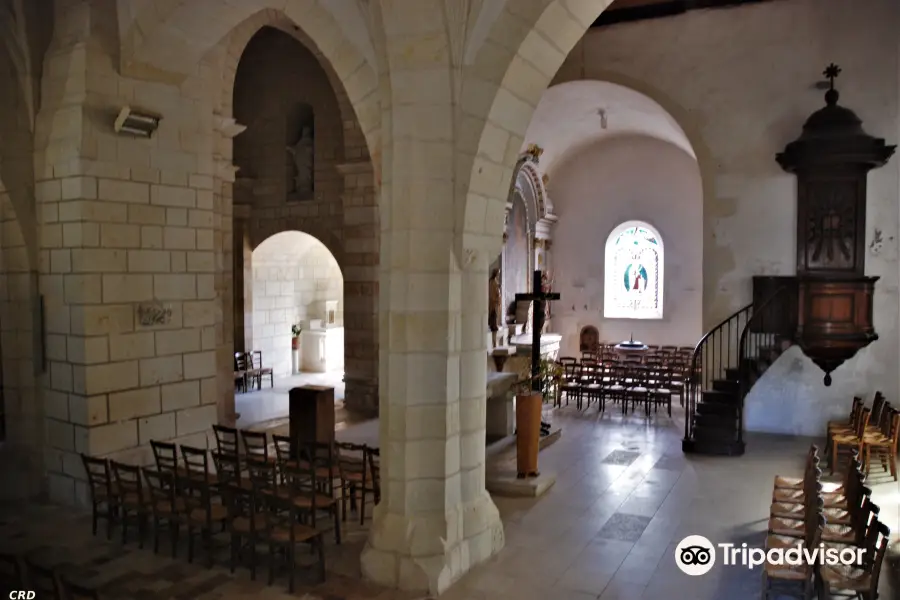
top-left (338, 159), bottom-right (379, 414)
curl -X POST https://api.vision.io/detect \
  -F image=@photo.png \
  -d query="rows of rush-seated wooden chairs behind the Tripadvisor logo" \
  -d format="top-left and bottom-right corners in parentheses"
top-left (762, 446), bottom-right (890, 600)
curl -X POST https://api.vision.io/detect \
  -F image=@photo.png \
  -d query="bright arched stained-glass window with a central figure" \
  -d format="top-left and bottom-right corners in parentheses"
top-left (603, 221), bottom-right (664, 319)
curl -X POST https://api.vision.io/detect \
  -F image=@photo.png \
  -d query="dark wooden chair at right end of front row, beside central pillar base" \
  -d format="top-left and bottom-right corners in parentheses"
top-left (254, 460), bottom-right (325, 594)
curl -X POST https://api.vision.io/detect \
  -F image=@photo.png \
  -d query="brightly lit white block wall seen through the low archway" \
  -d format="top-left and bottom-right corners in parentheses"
top-left (252, 231), bottom-right (344, 376)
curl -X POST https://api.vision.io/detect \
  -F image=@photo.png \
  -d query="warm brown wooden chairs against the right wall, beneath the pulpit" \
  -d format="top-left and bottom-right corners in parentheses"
top-left (826, 392), bottom-right (900, 481)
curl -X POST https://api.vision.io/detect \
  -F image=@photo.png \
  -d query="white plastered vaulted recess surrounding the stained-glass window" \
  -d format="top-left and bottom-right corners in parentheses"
top-left (524, 80), bottom-right (713, 351)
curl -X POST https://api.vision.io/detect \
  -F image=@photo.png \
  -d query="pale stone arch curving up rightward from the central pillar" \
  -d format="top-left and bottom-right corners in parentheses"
top-left (456, 0), bottom-right (612, 256)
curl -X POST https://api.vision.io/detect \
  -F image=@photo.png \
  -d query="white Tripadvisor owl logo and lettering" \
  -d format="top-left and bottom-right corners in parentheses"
top-left (675, 535), bottom-right (866, 577)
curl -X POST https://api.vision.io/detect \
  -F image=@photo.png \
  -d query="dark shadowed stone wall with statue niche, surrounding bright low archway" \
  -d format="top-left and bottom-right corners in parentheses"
top-left (234, 29), bottom-right (379, 412)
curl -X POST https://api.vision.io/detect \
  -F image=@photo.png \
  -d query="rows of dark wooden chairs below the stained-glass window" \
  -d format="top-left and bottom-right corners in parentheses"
top-left (556, 359), bottom-right (684, 417)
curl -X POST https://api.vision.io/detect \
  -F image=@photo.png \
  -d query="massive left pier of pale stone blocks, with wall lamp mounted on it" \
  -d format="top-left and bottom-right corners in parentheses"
top-left (35, 2), bottom-right (222, 504)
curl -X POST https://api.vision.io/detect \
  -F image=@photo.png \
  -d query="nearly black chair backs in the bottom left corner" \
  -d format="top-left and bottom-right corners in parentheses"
top-left (0, 553), bottom-right (100, 600)
